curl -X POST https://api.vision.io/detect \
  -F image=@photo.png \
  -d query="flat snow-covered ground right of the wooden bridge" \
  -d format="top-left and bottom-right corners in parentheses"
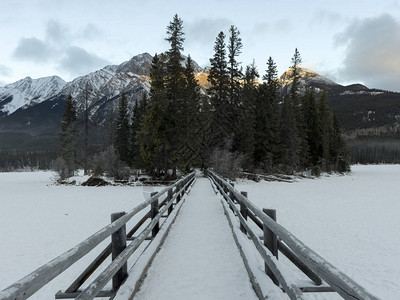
top-left (235, 165), bottom-right (400, 299)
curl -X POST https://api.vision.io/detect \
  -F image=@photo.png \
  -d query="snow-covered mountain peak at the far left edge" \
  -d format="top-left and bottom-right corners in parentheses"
top-left (0, 76), bottom-right (66, 116)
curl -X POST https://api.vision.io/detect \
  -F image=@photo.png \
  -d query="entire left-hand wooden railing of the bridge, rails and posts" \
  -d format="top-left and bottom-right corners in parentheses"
top-left (0, 172), bottom-right (195, 300)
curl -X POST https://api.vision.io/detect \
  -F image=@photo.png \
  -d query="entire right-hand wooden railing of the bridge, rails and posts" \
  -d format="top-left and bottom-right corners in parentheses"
top-left (208, 171), bottom-right (378, 300)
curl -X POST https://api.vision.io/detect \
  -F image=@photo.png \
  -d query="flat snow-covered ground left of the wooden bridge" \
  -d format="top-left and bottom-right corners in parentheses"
top-left (0, 172), bottom-right (161, 300)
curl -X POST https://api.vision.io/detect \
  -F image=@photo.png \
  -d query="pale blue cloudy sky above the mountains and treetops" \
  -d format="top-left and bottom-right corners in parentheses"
top-left (0, 0), bottom-right (400, 91)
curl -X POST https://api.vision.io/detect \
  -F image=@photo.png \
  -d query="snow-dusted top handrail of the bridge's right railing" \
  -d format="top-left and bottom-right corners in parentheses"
top-left (208, 171), bottom-right (378, 300)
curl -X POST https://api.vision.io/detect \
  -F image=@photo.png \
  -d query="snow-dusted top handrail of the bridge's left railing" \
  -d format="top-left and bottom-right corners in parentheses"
top-left (0, 172), bottom-right (194, 300)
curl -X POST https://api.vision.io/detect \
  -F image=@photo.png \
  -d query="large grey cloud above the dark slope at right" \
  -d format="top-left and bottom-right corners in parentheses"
top-left (335, 14), bottom-right (400, 91)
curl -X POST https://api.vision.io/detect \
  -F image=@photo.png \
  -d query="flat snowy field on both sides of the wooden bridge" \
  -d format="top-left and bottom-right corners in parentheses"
top-left (0, 166), bottom-right (400, 300)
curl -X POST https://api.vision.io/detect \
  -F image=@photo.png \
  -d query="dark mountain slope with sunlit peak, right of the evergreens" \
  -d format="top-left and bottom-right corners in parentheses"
top-left (280, 68), bottom-right (400, 137)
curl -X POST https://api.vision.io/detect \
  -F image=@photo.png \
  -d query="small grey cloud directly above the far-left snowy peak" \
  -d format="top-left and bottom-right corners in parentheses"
top-left (13, 37), bottom-right (52, 63)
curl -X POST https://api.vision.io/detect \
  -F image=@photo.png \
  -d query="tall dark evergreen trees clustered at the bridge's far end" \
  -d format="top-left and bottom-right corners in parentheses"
top-left (54, 15), bottom-right (349, 177)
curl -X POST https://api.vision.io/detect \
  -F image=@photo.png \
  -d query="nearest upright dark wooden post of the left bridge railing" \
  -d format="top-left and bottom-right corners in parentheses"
top-left (111, 212), bottom-right (128, 291)
